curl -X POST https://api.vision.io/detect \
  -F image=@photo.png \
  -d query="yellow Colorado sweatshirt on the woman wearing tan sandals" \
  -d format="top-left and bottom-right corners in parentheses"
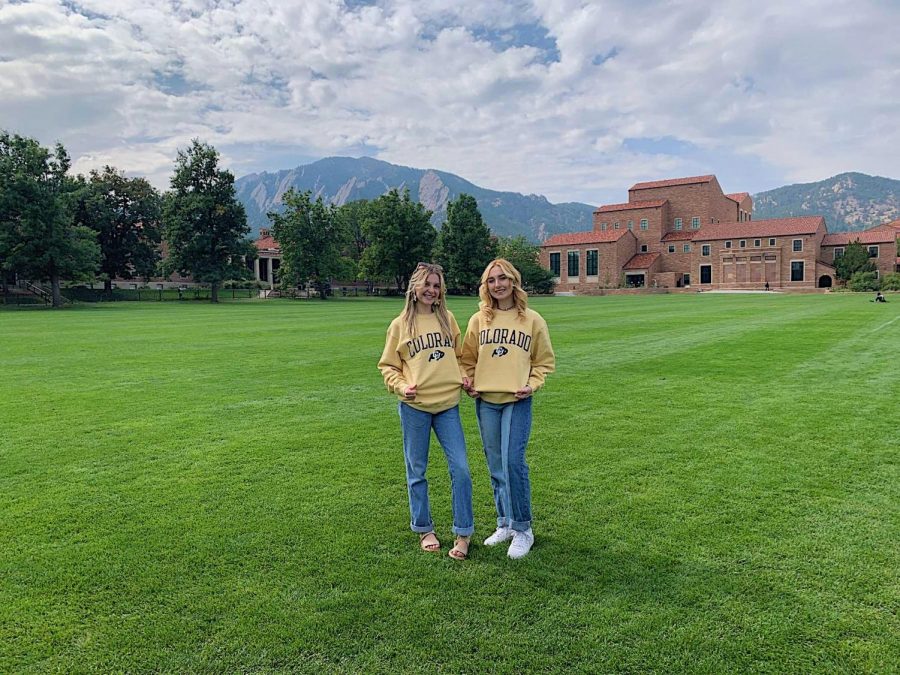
top-left (378, 312), bottom-right (464, 414)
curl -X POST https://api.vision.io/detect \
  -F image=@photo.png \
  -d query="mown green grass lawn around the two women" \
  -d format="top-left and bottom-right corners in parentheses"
top-left (0, 294), bottom-right (900, 673)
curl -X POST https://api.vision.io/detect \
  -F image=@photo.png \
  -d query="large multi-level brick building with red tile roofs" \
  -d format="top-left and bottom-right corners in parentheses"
top-left (541, 175), bottom-right (898, 293)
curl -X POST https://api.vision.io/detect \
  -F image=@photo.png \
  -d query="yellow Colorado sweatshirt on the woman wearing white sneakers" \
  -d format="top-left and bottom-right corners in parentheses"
top-left (461, 309), bottom-right (556, 403)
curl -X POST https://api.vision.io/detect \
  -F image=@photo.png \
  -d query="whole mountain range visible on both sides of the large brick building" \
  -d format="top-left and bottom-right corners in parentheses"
top-left (235, 157), bottom-right (900, 242)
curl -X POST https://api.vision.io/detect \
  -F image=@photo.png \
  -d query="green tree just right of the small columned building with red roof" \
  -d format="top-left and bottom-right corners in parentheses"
top-left (268, 188), bottom-right (341, 300)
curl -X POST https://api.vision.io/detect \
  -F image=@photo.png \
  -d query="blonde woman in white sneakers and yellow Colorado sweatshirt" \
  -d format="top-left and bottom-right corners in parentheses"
top-left (462, 258), bottom-right (556, 558)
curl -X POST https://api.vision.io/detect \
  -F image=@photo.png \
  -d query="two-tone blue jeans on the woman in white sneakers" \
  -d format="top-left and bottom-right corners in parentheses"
top-left (475, 396), bottom-right (531, 532)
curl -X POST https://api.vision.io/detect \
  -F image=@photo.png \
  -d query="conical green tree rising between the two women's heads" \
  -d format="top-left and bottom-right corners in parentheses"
top-left (435, 194), bottom-right (497, 294)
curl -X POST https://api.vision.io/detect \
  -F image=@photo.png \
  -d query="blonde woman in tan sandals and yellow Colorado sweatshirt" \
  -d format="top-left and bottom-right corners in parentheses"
top-left (378, 263), bottom-right (475, 560)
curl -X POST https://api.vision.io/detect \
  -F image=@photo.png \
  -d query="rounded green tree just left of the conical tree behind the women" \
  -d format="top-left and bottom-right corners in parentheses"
top-left (360, 190), bottom-right (437, 291)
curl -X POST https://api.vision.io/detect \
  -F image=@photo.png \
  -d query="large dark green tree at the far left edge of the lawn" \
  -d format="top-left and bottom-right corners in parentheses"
top-left (0, 131), bottom-right (100, 307)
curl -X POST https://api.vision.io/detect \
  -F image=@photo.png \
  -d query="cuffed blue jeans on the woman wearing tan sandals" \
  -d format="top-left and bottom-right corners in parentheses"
top-left (398, 403), bottom-right (475, 537)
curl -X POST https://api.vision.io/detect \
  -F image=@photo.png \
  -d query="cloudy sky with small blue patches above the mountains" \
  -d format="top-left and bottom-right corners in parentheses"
top-left (0, 0), bottom-right (900, 204)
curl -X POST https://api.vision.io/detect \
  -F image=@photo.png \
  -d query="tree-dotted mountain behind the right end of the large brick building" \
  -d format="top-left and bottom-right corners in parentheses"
top-left (753, 173), bottom-right (900, 232)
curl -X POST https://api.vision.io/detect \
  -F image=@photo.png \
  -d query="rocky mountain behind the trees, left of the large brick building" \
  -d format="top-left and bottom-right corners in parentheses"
top-left (235, 157), bottom-right (595, 242)
